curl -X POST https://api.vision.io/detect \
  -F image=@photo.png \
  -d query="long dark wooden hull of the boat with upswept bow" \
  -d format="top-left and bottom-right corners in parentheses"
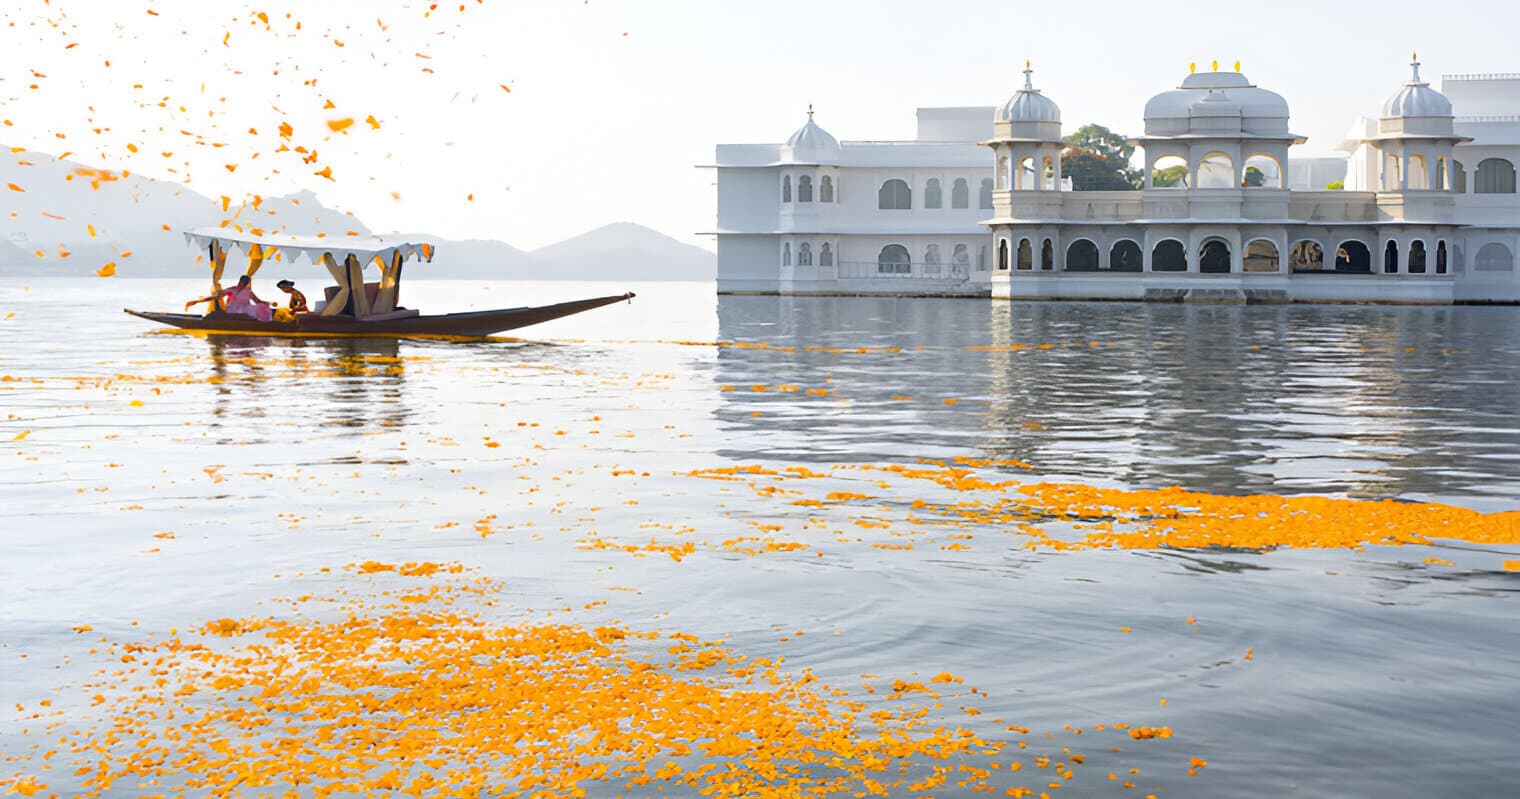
top-left (122, 292), bottom-right (634, 339)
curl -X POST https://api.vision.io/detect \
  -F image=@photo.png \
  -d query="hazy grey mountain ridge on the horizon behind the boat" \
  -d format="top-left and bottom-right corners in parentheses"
top-left (0, 152), bottom-right (717, 281)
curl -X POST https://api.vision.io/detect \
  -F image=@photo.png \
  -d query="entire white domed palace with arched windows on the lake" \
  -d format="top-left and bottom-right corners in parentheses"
top-left (711, 61), bottom-right (1520, 304)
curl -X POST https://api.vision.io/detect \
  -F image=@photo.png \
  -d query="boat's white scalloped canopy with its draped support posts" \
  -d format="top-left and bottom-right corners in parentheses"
top-left (185, 228), bottom-right (435, 317)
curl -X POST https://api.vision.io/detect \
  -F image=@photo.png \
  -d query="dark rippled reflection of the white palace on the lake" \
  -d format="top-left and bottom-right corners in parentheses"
top-left (714, 296), bottom-right (1520, 500)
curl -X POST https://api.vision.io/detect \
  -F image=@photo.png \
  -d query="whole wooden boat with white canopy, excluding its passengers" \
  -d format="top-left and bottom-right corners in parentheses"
top-left (122, 228), bottom-right (634, 339)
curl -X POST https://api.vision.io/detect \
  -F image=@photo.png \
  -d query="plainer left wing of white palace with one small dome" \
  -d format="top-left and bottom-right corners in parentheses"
top-left (711, 108), bottom-right (993, 295)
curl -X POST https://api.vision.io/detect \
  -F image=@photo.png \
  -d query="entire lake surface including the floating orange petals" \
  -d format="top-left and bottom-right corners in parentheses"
top-left (0, 278), bottom-right (1520, 797)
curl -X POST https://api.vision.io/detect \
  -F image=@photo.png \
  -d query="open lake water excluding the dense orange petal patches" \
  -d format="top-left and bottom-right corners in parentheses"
top-left (0, 278), bottom-right (1520, 797)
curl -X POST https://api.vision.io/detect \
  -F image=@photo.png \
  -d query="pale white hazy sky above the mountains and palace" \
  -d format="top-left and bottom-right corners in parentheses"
top-left (0, 0), bottom-right (1520, 248)
